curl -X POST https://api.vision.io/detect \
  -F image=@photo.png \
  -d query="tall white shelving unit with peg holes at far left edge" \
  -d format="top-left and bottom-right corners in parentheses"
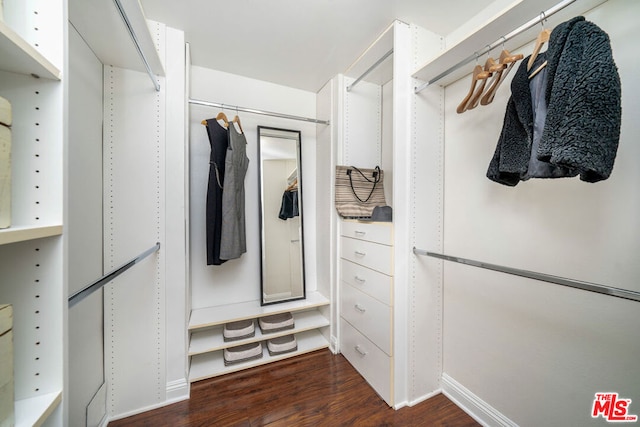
top-left (0, 0), bottom-right (66, 426)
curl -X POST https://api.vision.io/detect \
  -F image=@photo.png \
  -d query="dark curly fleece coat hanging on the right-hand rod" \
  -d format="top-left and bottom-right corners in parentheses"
top-left (487, 16), bottom-right (622, 186)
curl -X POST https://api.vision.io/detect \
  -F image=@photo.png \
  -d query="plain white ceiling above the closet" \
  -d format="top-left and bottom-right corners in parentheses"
top-left (140, 0), bottom-right (493, 92)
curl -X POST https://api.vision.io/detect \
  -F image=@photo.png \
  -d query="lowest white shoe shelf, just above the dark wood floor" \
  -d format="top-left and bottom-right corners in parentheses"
top-left (189, 330), bottom-right (329, 382)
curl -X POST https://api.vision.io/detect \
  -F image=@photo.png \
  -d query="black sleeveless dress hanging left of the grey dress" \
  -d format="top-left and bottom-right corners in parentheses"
top-left (206, 119), bottom-right (229, 265)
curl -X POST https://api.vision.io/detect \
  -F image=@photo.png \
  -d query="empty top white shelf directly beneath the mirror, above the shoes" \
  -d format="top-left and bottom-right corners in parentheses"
top-left (189, 292), bottom-right (329, 331)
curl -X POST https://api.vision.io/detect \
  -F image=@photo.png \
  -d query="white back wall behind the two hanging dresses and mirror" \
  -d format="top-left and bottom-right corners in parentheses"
top-left (189, 66), bottom-right (317, 309)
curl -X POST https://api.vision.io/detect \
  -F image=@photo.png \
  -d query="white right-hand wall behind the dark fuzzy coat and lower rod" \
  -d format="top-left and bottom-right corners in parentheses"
top-left (436, 0), bottom-right (640, 426)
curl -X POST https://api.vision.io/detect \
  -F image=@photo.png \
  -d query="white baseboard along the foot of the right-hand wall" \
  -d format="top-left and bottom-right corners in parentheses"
top-left (441, 373), bottom-right (518, 427)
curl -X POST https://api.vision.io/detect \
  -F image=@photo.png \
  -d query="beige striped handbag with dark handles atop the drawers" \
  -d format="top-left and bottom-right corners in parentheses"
top-left (335, 166), bottom-right (387, 219)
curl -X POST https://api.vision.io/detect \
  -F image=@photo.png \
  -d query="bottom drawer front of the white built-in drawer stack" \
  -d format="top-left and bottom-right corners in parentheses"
top-left (340, 320), bottom-right (393, 406)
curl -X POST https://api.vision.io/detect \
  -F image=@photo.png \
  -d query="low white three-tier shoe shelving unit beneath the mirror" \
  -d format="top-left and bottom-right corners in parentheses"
top-left (189, 292), bottom-right (330, 382)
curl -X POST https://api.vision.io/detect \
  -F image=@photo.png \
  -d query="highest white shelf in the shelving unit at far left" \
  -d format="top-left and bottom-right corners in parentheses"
top-left (0, 20), bottom-right (61, 80)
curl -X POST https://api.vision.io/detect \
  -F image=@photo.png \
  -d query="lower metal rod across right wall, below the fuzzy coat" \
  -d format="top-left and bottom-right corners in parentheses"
top-left (413, 247), bottom-right (640, 302)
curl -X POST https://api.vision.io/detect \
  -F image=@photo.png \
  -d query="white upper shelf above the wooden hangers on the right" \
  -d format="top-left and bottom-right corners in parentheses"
top-left (412, 0), bottom-right (607, 86)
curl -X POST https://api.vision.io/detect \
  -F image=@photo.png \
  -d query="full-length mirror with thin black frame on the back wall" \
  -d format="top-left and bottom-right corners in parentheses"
top-left (258, 126), bottom-right (305, 305)
